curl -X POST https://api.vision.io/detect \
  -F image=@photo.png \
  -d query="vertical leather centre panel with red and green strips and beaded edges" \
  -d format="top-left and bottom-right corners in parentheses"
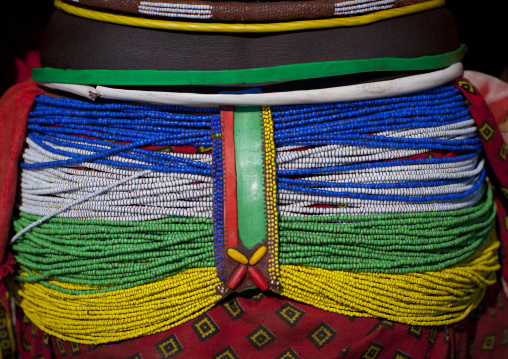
top-left (214, 106), bottom-right (280, 295)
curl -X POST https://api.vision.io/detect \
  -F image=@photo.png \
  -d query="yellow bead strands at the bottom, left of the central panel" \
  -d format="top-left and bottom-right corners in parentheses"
top-left (9, 267), bottom-right (222, 344)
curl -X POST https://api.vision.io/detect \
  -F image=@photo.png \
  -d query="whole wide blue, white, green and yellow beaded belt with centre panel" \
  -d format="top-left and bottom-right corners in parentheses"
top-left (7, 80), bottom-right (499, 343)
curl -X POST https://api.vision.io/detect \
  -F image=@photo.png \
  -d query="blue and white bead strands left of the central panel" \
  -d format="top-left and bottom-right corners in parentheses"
top-left (18, 95), bottom-right (214, 221)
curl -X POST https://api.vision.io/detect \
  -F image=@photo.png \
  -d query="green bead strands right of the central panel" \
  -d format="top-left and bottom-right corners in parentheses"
top-left (279, 190), bottom-right (496, 273)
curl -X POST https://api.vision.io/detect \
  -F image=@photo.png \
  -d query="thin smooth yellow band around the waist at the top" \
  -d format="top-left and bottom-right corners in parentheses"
top-left (55, 0), bottom-right (445, 32)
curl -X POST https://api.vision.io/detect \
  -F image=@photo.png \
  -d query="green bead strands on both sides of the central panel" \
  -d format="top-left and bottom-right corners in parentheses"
top-left (13, 189), bottom-right (496, 294)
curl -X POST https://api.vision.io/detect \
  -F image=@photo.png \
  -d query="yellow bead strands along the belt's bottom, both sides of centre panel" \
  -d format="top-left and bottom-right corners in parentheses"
top-left (9, 226), bottom-right (500, 344)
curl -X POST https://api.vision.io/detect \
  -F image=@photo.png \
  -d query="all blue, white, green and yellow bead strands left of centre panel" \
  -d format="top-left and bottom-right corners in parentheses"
top-left (13, 96), bottom-right (221, 344)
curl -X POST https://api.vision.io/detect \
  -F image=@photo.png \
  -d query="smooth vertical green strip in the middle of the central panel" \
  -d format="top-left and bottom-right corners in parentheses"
top-left (234, 106), bottom-right (267, 249)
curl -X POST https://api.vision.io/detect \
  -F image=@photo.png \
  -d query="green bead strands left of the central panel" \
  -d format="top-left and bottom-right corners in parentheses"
top-left (13, 212), bottom-right (214, 294)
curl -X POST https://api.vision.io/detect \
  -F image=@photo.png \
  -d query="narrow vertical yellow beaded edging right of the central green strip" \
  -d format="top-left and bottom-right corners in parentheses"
top-left (262, 106), bottom-right (279, 281)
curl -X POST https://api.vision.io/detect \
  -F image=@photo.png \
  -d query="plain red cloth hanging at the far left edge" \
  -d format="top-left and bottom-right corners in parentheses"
top-left (0, 81), bottom-right (44, 268)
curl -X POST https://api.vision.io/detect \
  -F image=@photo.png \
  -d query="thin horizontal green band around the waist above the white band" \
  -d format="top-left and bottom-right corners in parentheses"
top-left (32, 45), bottom-right (466, 86)
